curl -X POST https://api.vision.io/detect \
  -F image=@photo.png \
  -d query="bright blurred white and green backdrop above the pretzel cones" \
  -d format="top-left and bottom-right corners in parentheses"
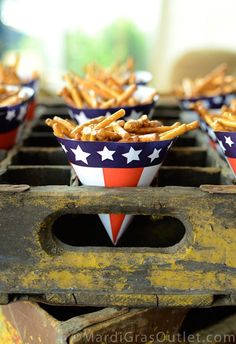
top-left (0, 0), bottom-right (236, 92)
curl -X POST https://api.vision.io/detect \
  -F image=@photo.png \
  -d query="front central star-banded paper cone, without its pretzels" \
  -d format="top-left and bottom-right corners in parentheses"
top-left (58, 138), bottom-right (173, 244)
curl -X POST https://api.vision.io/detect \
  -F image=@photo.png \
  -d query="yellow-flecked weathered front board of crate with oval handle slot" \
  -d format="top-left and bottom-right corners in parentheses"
top-left (0, 186), bottom-right (236, 306)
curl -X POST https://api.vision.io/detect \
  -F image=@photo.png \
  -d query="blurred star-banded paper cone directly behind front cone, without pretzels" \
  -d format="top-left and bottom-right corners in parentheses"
top-left (66, 86), bottom-right (158, 124)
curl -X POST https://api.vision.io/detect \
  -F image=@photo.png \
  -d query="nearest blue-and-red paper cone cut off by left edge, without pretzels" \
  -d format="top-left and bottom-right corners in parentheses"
top-left (0, 86), bottom-right (34, 149)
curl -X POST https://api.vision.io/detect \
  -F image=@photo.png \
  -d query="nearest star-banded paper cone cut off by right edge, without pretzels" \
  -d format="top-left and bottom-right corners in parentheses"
top-left (215, 131), bottom-right (236, 177)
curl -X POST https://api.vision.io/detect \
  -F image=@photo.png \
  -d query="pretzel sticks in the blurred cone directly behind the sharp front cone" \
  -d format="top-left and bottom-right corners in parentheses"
top-left (59, 63), bottom-right (157, 109)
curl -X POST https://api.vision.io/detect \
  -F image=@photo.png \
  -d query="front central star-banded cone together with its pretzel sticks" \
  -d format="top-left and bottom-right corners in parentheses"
top-left (46, 109), bottom-right (199, 244)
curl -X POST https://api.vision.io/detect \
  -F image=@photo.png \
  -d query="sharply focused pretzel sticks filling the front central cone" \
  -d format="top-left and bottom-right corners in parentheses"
top-left (46, 109), bottom-right (199, 142)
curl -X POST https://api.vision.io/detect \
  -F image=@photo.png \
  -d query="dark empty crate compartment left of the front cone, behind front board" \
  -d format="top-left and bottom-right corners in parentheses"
top-left (0, 166), bottom-right (71, 186)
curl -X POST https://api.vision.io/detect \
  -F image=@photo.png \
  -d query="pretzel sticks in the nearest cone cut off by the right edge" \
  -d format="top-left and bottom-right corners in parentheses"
top-left (193, 101), bottom-right (236, 131)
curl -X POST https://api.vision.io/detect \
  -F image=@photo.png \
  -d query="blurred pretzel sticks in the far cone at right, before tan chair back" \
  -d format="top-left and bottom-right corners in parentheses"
top-left (174, 63), bottom-right (236, 98)
